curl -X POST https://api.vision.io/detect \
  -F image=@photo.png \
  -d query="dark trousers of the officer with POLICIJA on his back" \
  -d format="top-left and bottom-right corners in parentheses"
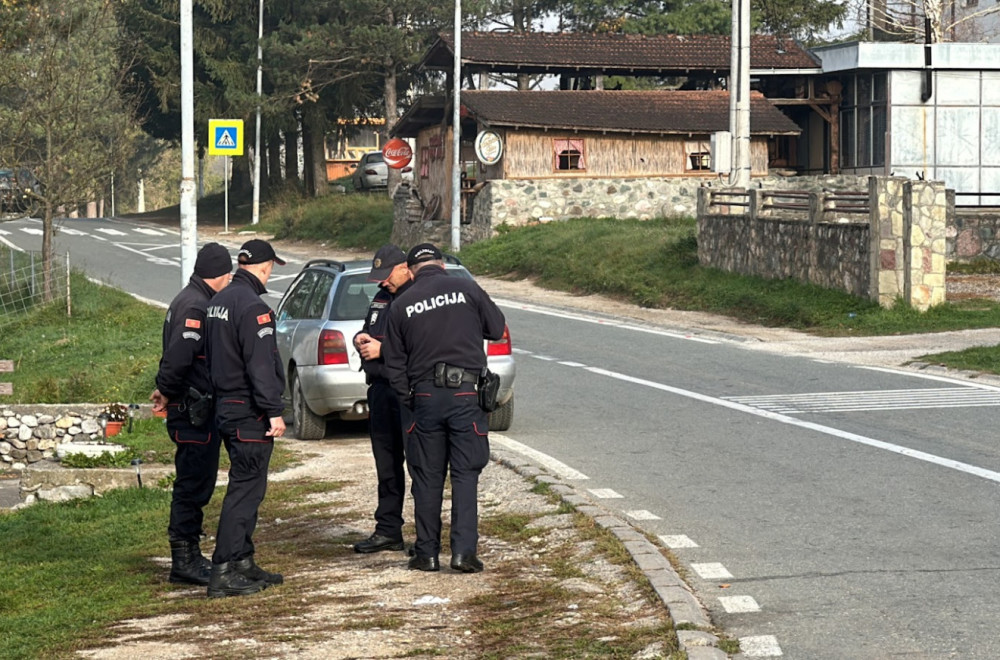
top-left (406, 381), bottom-right (490, 557)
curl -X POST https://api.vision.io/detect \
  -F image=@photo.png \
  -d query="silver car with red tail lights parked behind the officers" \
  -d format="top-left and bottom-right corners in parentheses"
top-left (276, 256), bottom-right (515, 440)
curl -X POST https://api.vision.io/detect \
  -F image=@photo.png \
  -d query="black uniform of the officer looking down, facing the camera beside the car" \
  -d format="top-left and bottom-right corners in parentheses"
top-left (361, 282), bottom-right (411, 541)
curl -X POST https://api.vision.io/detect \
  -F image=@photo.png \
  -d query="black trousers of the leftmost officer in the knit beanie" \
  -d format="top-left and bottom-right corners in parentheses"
top-left (167, 404), bottom-right (221, 542)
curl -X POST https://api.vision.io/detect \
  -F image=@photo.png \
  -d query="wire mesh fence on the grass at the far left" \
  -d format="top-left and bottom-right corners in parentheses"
top-left (0, 245), bottom-right (70, 327)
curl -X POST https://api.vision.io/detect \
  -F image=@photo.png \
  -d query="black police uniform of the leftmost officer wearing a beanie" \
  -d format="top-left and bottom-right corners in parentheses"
top-left (156, 275), bottom-right (220, 543)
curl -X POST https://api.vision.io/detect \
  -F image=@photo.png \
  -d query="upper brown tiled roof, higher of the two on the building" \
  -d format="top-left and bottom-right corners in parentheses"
top-left (422, 32), bottom-right (820, 75)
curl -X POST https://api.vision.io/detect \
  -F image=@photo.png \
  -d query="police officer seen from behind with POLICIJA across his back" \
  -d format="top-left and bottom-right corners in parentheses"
top-left (382, 243), bottom-right (504, 573)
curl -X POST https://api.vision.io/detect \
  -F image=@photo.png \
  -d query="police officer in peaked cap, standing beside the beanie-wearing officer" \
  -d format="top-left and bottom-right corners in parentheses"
top-left (206, 239), bottom-right (285, 598)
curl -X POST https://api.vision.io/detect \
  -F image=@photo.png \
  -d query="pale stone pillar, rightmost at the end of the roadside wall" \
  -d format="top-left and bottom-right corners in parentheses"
top-left (905, 181), bottom-right (948, 311)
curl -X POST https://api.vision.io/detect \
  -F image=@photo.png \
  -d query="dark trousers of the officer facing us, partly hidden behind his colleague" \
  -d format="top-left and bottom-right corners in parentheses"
top-left (368, 378), bottom-right (410, 539)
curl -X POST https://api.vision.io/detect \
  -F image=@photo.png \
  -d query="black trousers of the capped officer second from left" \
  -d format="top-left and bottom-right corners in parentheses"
top-left (212, 399), bottom-right (274, 564)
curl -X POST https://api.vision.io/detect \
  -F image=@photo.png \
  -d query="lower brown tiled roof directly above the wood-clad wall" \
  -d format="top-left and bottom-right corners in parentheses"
top-left (462, 91), bottom-right (801, 135)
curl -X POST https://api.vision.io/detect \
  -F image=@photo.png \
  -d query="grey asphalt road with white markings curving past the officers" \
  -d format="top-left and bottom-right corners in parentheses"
top-left (0, 215), bottom-right (1000, 660)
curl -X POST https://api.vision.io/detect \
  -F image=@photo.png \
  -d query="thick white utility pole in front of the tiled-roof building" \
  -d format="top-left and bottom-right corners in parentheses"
top-left (729, 0), bottom-right (750, 188)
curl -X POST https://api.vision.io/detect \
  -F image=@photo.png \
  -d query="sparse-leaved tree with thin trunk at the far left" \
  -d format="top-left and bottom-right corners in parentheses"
top-left (0, 0), bottom-right (136, 299)
